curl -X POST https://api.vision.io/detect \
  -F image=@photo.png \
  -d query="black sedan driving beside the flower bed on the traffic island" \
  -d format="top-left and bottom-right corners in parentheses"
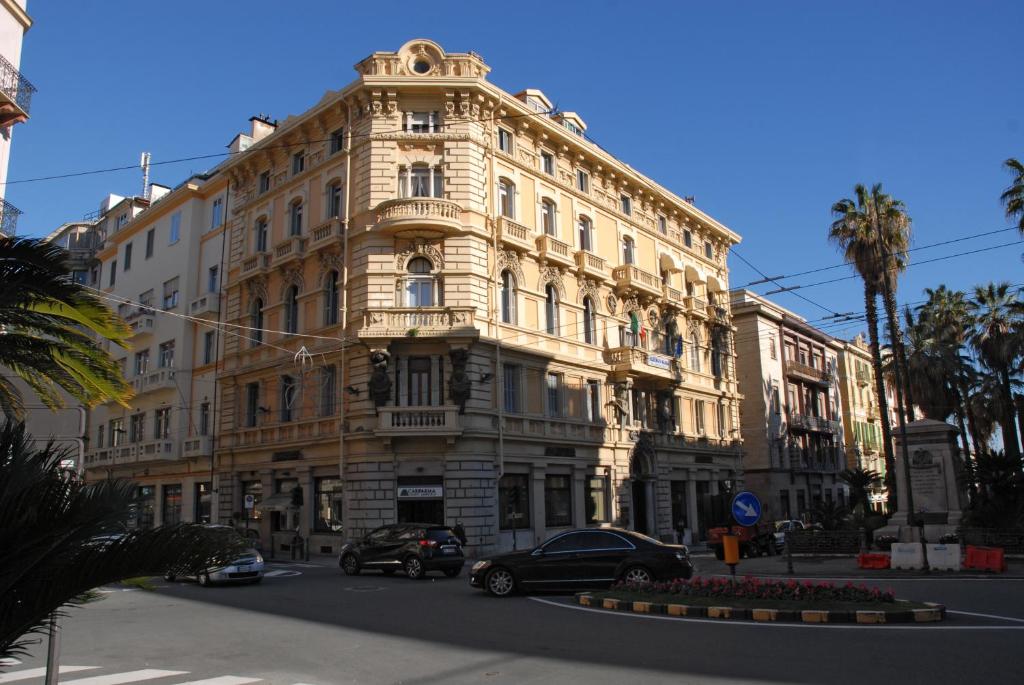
top-left (469, 528), bottom-right (693, 597)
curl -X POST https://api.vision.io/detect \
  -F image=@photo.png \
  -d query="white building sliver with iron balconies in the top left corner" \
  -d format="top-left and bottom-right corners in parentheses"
top-left (0, 0), bottom-right (36, 236)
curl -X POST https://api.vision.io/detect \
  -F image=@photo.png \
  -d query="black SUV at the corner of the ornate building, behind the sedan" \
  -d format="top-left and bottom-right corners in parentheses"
top-left (338, 523), bottom-right (466, 580)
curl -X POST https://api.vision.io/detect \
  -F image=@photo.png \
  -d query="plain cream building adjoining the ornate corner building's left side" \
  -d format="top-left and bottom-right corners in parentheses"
top-left (81, 178), bottom-right (227, 527)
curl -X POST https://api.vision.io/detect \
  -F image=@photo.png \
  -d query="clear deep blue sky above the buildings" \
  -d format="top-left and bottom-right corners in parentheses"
top-left (7, 0), bottom-right (1024, 336)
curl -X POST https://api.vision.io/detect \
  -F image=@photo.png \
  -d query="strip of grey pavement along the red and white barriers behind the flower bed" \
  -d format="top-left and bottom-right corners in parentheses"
top-left (693, 554), bottom-right (1024, 580)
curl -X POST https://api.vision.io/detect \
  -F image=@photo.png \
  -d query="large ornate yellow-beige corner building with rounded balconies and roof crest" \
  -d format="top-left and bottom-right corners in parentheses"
top-left (216, 40), bottom-right (740, 553)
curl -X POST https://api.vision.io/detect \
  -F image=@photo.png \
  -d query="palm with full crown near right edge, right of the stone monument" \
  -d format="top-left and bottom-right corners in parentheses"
top-left (971, 283), bottom-right (1024, 460)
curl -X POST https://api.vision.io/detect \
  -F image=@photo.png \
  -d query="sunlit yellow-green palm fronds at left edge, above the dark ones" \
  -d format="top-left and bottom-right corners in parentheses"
top-left (0, 236), bottom-right (131, 419)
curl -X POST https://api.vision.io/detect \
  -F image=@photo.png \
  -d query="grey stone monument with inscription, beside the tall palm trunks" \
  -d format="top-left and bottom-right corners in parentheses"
top-left (874, 419), bottom-right (967, 543)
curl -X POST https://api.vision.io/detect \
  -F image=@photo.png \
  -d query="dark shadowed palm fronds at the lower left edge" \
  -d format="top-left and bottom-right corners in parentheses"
top-left (0, 422), bottom-right (245, 658)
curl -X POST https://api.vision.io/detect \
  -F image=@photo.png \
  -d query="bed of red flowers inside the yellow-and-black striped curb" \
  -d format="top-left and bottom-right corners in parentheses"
top-left (611, 576), bottom-right (896, 604)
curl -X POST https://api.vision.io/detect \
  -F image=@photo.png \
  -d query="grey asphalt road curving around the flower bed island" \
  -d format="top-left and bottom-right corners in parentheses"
top-left (6, 559), bottom-right (1024, 685)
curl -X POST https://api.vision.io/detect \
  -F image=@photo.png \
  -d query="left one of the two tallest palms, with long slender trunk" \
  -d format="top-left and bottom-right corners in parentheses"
top-left (828, 183), bottom-right (897, 509)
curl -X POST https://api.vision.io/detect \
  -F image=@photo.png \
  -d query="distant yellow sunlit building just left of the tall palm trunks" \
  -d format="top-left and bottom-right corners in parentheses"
top-left (838, 335), bottom-right (888, 511)
